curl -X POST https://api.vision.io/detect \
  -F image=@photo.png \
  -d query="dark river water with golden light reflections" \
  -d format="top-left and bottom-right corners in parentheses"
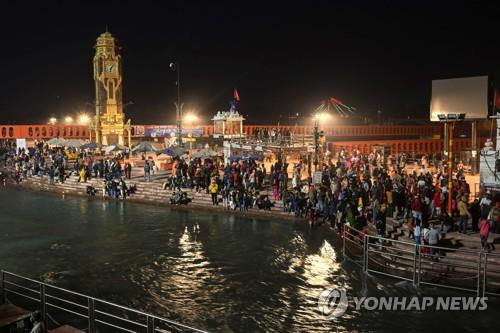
top-left (0, 188), bottom-right (499, 332)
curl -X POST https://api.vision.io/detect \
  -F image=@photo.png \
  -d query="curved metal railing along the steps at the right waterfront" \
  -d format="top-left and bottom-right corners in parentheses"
top-left (342, 224), bottom-right (500, 297)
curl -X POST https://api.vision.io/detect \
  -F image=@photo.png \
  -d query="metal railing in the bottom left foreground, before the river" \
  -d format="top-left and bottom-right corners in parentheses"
top-left (0, 270), bottom-right (206, 333)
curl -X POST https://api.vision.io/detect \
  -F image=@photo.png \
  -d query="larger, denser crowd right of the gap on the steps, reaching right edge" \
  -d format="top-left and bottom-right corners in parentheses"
top-left (156, 145), bottom-right (500, 252)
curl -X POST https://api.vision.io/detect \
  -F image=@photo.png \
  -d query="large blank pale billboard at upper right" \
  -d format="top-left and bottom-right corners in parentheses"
top-left (430, 76), bottom-right (491, 121)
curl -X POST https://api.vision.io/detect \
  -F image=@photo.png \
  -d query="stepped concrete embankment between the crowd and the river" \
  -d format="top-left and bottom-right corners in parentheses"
top-left (4, 169), bottom-right (500, 290)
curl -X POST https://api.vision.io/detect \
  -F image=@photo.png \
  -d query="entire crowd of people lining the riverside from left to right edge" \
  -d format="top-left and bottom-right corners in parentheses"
top-left (3, 135), bottom-right (500, 252)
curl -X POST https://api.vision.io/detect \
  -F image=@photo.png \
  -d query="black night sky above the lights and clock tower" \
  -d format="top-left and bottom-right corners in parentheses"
top-left (0, 0), bottom-right (500, 124)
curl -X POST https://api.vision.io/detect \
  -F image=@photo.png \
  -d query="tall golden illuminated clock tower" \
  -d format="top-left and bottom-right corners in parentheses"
top-left (92, 31), bottom-right (131, 147)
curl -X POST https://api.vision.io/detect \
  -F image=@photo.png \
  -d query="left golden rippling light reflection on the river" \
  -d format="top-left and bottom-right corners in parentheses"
top-left (137, 224), bottom-right (226, 324)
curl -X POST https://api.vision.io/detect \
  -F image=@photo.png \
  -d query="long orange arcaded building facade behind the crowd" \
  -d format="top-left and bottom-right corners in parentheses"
top-left (0, 124), bottom-right (486, 154)
